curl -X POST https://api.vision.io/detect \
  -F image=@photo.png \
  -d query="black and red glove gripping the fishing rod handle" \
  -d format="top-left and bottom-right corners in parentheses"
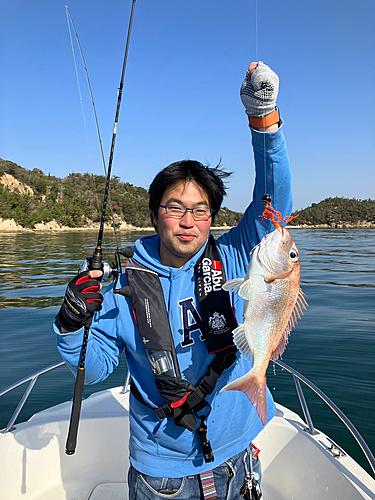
top-left (56, 271), bottom-right (103, 332)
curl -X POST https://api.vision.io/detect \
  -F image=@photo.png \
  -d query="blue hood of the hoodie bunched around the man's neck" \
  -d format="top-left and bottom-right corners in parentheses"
top-left (134, 234), bottom-right (207, 277)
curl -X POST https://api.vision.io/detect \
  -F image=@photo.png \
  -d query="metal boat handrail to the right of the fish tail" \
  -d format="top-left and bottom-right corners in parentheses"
top-left (275, 360), bottom-right (375, 476)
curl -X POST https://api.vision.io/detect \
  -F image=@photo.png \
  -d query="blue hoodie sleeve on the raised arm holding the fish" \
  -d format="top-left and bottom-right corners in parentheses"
top-left (217, 120), bottom-right (293, 279)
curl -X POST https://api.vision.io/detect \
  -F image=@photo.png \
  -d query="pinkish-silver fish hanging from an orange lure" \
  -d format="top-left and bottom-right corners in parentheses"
top-left (221, 225), bottom-right (307, 425)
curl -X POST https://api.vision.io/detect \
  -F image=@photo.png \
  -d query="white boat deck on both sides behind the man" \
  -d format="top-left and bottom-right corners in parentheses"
top-left (0, 387), bottom-right (375, 500)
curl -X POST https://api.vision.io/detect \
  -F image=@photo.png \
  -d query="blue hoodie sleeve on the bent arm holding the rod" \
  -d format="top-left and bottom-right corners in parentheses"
top-left (54, 286), bottom-right (124, 384)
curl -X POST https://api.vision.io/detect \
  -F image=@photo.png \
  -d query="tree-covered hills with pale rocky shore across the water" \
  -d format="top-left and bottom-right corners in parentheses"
top-left (0, 159), bottom-right (375, 233)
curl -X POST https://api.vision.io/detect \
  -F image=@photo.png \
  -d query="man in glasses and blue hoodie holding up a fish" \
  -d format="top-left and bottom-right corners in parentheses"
top-left (56, 62), bottom-right (292, 500)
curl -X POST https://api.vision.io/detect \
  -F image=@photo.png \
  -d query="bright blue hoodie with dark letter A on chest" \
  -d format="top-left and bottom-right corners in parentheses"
top-left (55, 127), bottom-right (292, 477)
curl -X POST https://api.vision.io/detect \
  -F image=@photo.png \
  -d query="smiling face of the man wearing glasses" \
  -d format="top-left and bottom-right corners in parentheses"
top-left (154, 182), bottom-right (211, 268)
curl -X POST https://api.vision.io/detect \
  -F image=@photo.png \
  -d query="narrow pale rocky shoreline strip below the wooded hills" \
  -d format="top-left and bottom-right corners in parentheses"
top-left (0, 218), bottom-right (375, 234)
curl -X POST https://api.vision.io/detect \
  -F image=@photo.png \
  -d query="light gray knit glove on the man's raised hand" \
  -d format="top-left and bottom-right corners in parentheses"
top-left (240, 61), bottom-right (279, 117)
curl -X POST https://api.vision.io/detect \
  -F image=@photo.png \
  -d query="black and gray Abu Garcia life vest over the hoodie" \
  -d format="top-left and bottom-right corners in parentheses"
top-left (126, 236), bottom-right (237, 461)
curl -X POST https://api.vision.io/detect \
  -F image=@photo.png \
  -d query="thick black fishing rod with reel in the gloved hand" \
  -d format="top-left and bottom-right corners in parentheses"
top-left (65, 0), bottom-right (136, 455)
